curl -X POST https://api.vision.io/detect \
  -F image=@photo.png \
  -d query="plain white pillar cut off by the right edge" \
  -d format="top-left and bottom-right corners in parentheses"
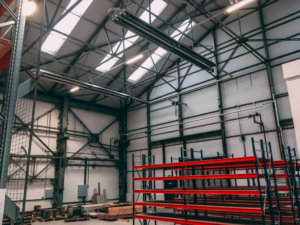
top-left (282, 60), bottom-right (300, 157)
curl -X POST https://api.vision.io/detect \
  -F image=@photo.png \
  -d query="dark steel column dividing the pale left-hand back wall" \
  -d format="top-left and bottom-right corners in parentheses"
top-left (53, 97), bottom-right (69, 207)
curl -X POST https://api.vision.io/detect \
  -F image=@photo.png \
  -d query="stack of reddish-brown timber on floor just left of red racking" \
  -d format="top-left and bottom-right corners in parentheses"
top-left (98, 203), bottom-right (143, 220)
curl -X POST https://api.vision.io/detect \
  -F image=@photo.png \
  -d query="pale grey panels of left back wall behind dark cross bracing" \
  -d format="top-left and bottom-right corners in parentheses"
top-left (7, 99), bottom-right (119, 210)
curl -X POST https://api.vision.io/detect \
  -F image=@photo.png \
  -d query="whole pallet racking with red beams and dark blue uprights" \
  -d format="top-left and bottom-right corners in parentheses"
top-left (132, 140), bottom-right (299, 225)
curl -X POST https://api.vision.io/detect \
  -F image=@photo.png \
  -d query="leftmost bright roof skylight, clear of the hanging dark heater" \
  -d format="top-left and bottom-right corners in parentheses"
top-left (42, 0), bottom-right (93, 55)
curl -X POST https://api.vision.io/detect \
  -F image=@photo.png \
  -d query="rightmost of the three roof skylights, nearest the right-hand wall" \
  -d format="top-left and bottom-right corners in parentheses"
top-left (128, 20), bottom-right (195, 83)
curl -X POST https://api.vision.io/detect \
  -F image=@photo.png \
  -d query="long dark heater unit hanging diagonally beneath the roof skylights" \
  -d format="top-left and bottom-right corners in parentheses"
top-left (108, 8), bottom-right (216, 70)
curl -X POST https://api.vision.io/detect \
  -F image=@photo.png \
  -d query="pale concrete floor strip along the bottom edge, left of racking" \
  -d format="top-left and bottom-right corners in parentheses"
top-left (34, 219), bottom-right (174, 225)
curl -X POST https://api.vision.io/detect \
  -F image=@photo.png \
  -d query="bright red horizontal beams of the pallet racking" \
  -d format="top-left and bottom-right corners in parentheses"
top-left (133, 151), bottom-right (274, 225)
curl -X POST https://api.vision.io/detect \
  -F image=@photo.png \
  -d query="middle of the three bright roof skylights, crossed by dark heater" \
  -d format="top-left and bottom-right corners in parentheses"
top-left (96, 0), bottom-right (167, 72)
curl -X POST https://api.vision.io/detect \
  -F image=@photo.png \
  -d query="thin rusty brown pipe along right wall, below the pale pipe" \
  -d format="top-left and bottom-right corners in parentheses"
top-left (116, 114), bottom-right (257, 143)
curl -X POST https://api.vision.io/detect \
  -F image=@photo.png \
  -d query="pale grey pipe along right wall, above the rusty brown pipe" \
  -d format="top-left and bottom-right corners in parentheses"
top-left (120, 101), bottom-right (273, 137)
